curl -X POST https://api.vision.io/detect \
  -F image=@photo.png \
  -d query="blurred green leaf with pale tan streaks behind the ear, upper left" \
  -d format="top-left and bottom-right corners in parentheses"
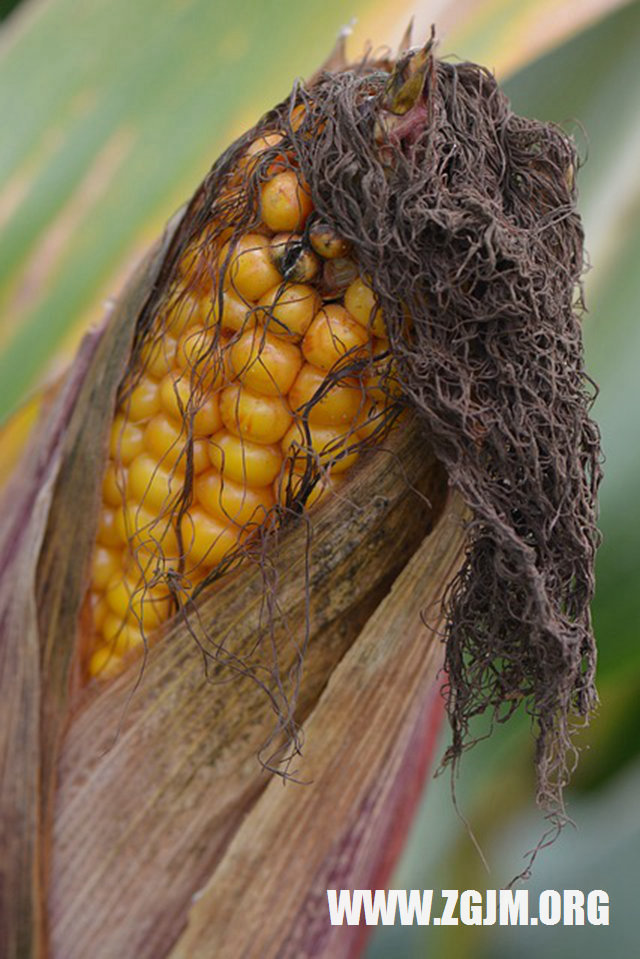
top-left (0, 0), bottom-right (632, 421)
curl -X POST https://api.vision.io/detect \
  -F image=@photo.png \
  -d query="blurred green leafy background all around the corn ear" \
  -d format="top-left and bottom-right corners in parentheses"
top-left (0, 0), bottom-right (640, 959)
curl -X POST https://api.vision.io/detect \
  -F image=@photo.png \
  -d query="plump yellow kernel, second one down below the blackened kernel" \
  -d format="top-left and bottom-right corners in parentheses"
top-left (230, 327), bottom-right (302, 396)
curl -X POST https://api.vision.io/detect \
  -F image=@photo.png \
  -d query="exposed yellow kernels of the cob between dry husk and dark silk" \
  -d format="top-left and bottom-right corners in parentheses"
top-left (85, 129), bottom-right (394, 678)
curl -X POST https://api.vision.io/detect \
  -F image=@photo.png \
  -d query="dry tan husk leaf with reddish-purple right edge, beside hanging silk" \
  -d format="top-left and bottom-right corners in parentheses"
top-left (170, 496), bottom-right (465, 959)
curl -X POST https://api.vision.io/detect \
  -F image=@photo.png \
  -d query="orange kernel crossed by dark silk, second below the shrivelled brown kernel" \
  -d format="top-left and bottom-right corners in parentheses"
top-left (288, 363), bottom-right (366, 426)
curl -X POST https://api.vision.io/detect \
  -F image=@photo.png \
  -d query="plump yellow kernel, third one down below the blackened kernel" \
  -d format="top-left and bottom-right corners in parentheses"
top-left (220, 383), bottom-right (293, 445)
